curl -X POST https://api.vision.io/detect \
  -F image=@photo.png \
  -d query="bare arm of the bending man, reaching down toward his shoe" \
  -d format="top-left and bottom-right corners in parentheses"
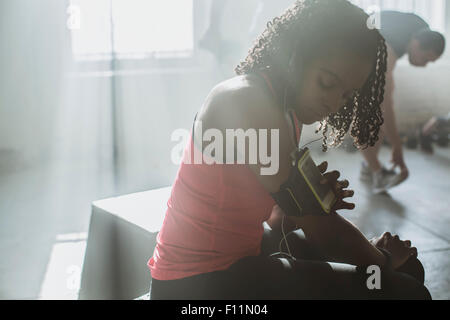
top-left (381, 45), bottom-right (409, 178)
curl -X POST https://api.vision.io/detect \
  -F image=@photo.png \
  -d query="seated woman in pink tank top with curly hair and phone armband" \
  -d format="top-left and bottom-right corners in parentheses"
top-left (148, 0), bottom-right (431, 300)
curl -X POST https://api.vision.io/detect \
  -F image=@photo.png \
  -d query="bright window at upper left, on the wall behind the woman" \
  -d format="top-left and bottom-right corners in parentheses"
top-left (67, 0), bottom-right (194, 58)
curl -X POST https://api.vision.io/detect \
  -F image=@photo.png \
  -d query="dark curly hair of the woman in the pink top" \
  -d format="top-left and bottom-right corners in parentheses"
top-left (235, 0), bottom-right (387, 151)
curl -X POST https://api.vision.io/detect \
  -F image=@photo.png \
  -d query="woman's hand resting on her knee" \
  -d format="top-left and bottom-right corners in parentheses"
top-left (370, 232), bottom-right (417, 269)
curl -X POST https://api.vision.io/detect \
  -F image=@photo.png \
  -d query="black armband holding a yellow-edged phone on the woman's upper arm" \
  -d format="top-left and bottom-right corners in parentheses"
top-left (271, 148), bottom-right (336, 217)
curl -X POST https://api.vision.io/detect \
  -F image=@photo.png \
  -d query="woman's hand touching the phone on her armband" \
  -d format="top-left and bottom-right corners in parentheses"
top-left (318, 161), bottom-right (355, 211)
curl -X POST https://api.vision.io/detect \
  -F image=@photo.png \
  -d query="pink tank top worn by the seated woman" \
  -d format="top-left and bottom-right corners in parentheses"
top-left (147, 74), bottom-right (300, 280)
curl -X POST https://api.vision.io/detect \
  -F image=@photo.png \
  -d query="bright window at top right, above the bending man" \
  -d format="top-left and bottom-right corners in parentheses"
top-left (350, 0), bottom-right (445, 32)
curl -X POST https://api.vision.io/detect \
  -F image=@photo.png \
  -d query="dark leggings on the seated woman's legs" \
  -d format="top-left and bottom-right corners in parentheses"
top-left (151, 229), bottom-right (431, 300)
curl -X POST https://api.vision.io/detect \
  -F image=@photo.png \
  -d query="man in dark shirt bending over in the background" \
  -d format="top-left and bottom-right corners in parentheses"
top-left (361, 11), bottom-right (445, 193)
